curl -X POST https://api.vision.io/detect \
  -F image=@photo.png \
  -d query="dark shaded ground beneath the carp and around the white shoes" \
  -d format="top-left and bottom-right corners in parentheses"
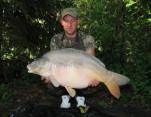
top-left (1, 78), bottom-right (150, 117)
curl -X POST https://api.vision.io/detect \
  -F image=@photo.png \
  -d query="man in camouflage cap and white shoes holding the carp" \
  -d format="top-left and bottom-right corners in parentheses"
top-left (42, 8), bottom-right (99, 108)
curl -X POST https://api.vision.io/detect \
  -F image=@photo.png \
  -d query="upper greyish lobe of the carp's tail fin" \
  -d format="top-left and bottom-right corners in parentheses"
top-left (108, 71), bottom-right (130, 86)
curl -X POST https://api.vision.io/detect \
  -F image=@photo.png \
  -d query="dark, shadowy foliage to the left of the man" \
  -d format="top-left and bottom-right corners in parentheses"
top-left (0, 0), bottom-right (71, 81)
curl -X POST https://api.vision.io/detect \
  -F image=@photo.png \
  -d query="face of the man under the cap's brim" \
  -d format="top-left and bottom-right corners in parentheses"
top-left (61, 15), bottom-right (79, 35)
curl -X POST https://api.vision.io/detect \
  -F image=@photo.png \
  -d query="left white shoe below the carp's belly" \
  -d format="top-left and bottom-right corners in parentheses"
top-left (60, 95), bottom-right (71, 109)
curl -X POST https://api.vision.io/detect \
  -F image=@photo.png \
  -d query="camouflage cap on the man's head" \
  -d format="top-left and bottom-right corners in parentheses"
top-left (61, 8), bottom-right (78, 18)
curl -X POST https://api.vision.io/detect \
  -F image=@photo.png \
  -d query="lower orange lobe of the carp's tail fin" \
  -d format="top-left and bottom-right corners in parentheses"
top-left (104, 77), bottom-right (120, 99)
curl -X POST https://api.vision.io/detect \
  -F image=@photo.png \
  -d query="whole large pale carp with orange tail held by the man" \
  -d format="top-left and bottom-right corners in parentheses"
top-left (27, 48), bottom-right (129, 98)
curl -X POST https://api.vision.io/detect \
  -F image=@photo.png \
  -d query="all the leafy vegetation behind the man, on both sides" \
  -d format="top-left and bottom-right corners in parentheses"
top-left (0, 0), bottom-right (151, 114)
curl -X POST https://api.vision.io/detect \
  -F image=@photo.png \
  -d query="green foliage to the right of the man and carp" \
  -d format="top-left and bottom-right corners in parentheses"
top-left (72, 0), bottom-right (151, 107)
